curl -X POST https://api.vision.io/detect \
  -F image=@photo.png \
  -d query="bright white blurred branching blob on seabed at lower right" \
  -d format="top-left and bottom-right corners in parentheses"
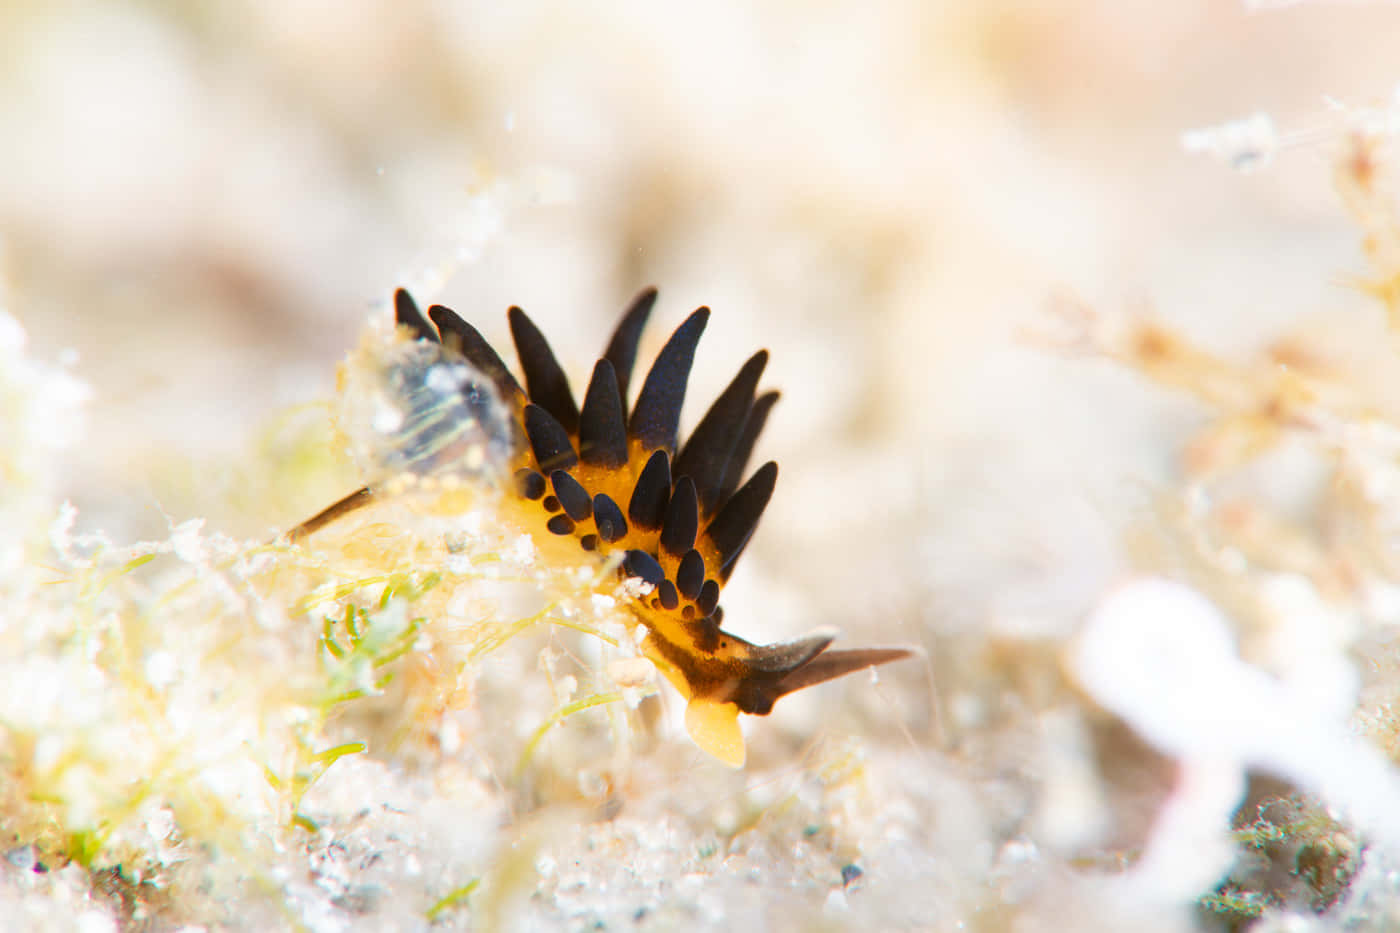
top-left (1070, 579), bottom-right (1400, 899)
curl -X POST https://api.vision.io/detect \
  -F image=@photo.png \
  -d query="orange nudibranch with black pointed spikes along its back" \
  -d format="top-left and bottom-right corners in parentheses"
top-left (287, 289), bottom-right (913, 768)
